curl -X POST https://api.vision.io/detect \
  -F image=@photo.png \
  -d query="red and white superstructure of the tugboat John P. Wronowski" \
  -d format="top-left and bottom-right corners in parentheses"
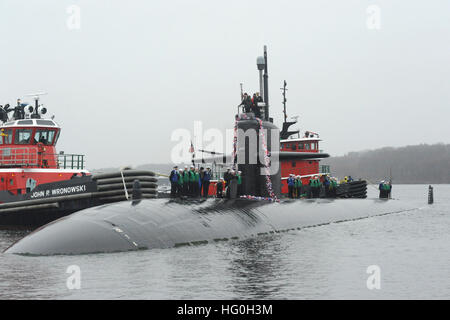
top-left (0, 94), bottom-right (90, 196)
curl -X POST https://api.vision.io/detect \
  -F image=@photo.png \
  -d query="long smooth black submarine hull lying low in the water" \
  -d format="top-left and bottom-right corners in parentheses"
top-left (6, 199), bottom-right (415, 255)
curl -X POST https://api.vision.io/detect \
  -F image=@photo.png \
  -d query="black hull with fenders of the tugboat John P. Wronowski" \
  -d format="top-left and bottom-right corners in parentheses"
top-left (0, 170), bottom-right (157, 228)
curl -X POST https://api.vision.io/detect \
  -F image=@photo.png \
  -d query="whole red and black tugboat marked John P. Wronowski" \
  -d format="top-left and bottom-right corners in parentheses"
top-left (0, 94), bottom-right (157, 228)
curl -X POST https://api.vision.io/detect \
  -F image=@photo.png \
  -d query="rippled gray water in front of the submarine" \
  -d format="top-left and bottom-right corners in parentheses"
top-left (0, 185), bottom-right (450, 299)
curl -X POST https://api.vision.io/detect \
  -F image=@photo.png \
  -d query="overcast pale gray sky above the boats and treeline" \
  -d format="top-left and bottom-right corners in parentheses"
top-left (0, 0), bottom-right (450, 168)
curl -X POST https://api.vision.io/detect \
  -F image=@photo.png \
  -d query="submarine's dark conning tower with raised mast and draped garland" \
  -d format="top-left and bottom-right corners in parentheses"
top-left (233, 46), bottom-right (281, 197)
